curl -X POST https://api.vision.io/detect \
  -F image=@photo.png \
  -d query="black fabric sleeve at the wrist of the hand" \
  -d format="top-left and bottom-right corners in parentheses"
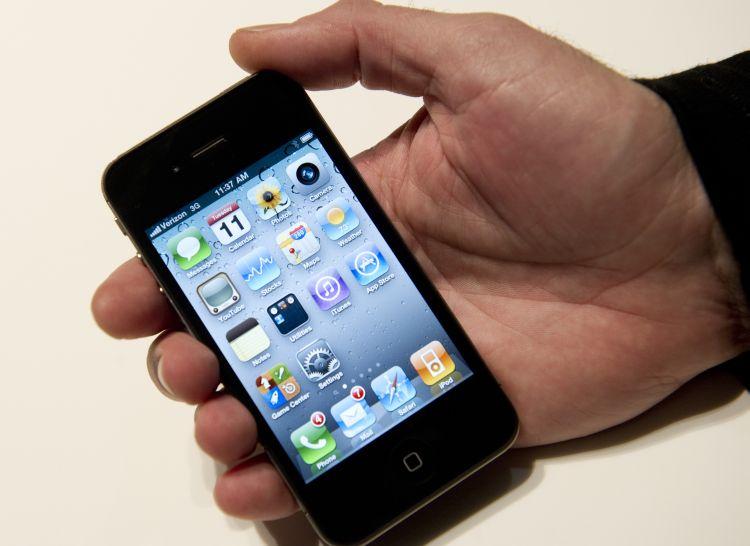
top-left (638, 51), bottom-right (750, 297)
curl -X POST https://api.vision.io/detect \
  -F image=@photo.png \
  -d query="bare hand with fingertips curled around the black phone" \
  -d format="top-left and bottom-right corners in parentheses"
top-left (93, 1), bottom-right (746, 519)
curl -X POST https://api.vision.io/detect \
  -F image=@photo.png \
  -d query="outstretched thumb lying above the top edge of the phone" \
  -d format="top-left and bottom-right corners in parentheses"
top-left (230, 0), bottom-right (506, 100)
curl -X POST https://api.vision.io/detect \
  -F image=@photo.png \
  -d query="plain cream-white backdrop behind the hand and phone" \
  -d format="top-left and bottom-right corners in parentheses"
top-left (0, 0), bottom-right (750, 546)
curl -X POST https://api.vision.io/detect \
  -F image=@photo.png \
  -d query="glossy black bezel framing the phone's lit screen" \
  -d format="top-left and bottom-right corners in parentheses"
top-left (102, 71), bottom-right (518, 544)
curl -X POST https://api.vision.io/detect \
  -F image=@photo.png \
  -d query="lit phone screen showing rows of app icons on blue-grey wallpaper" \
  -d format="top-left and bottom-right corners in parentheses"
top-left (146, 131), bottom-right (472, 482)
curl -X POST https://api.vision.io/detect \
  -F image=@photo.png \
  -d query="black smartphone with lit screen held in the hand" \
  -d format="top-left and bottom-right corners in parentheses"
top-left (103, 72), bottom-right (518, 544)
